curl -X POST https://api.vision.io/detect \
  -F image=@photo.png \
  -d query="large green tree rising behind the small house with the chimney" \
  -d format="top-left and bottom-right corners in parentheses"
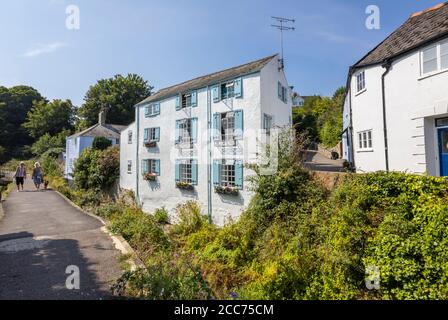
top-left (77, 74), bottom-right (153, 129)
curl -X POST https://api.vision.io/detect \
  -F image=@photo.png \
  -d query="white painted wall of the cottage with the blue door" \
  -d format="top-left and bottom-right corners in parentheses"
top-left (351, 36), bottom-right (448, 175)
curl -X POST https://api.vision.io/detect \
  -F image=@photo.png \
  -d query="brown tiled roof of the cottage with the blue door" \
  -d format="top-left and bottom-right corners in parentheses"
top-left (355, 2), bottom-right (448, 67)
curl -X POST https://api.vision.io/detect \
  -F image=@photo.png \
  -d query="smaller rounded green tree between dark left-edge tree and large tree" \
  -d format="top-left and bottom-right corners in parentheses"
top-left (23, 100), bottom-right (74, 139)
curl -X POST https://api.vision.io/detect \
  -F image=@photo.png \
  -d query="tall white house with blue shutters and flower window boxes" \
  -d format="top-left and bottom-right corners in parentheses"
top-left (120, 55), bottom-right (292, 225)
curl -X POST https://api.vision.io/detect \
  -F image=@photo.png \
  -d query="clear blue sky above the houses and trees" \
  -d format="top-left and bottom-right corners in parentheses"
top-left (0, 0), bottom-right (442, 105)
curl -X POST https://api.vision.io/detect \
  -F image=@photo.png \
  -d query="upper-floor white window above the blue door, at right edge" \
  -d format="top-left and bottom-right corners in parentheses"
top-left (421, 40), bottom-right (448, 76)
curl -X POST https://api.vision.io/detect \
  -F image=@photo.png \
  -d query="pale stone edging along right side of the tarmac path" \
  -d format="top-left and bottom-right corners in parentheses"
top-left (53, 189), bottom-right (145, 271)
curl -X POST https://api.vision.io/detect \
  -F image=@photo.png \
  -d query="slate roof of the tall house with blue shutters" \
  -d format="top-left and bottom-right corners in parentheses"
top-left (139, 54), bottom-right (277, 105)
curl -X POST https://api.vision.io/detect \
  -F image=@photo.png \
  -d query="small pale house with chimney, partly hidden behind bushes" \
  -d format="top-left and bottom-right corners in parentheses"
top-left (64, 112), bottom-right (126, 180)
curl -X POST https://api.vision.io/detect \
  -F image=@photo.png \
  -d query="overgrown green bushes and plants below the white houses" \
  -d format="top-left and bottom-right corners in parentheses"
top-left (80, 130), bottom-right (448, 299)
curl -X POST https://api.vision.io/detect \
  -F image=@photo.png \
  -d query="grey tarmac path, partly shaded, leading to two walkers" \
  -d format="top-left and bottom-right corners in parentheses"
top-left (0, 179), bottom-right (122, 300)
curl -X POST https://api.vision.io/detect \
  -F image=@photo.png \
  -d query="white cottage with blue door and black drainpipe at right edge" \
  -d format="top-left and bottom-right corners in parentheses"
top-left (343, 3), bottom-right (448, 176)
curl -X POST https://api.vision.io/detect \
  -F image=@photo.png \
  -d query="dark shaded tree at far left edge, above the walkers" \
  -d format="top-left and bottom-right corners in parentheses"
top-left (0, 86), bottom-right (45, 158)
